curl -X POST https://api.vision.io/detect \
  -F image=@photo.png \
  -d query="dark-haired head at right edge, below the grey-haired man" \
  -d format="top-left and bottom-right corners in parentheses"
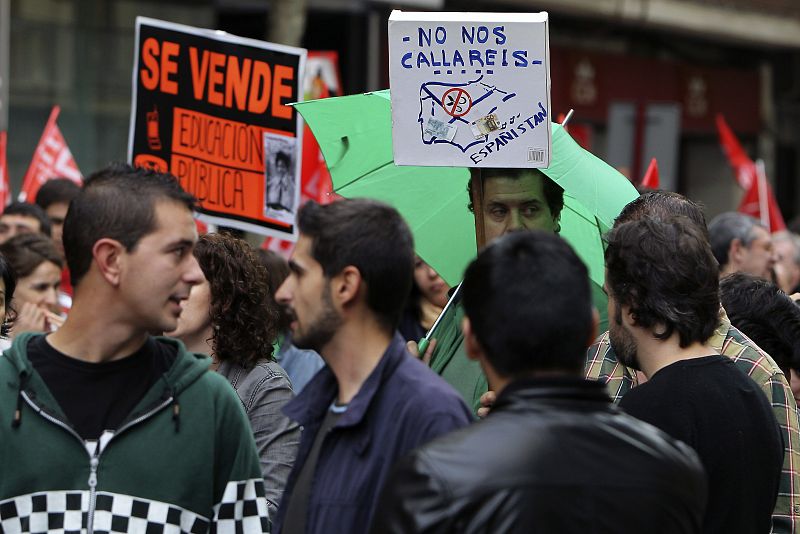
top-left (719, 273), bottom-right (800, 378)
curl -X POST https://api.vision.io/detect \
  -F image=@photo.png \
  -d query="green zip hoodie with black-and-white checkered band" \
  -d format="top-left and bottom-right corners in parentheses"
top-left (0, 334), bottom-right (270, 534)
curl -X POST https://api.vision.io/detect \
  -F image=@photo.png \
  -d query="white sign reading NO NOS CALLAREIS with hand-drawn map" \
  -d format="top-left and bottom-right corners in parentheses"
top-left (389, 11), bottom-right (551, 167)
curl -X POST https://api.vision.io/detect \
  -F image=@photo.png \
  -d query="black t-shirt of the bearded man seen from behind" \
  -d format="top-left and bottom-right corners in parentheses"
top-left (619, 356), bottom-right (783, 534)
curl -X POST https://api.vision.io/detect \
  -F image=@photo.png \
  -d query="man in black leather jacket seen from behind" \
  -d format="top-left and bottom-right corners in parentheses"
top-left (372, 232), bottom-right (706, 534)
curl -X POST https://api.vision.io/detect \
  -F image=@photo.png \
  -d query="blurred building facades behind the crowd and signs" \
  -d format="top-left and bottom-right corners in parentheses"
top-left (0, 0), bottom-right (800, 222)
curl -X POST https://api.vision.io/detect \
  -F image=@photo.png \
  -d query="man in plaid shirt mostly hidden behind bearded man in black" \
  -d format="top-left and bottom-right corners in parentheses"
top-left (584, 191), bottom-right (800, 534)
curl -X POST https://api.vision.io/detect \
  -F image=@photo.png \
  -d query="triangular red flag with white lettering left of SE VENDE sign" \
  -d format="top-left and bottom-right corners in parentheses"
top-left (19, 106), bottom-right (83, 202)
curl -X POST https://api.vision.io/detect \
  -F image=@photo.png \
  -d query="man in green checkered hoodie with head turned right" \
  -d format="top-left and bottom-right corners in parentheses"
top-left (0, 165), bottom-right (269, 533)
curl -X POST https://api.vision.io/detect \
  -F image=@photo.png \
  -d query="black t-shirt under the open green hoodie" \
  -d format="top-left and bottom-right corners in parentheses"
top-left (27, 336), bottom-right (177, 440)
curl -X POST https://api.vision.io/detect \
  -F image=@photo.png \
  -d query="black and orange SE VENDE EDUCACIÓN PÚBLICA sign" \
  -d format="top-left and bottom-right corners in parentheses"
top-left (128, 17), bottom-right (306, 240)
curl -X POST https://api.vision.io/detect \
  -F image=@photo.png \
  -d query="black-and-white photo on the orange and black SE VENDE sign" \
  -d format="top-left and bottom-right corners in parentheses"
top-left (264, 133), bottom-right (298, 226)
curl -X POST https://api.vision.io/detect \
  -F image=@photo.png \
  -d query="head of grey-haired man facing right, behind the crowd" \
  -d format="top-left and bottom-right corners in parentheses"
top-left (708, 211), bottom-right (777, 280)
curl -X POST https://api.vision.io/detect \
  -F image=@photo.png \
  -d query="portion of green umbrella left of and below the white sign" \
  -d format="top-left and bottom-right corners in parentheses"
top-left (295, 91), bottom-right (476, 286)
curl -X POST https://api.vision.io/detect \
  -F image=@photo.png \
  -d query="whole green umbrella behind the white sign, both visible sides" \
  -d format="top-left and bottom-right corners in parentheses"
top-left (296, 91), bottom-right (637, 298)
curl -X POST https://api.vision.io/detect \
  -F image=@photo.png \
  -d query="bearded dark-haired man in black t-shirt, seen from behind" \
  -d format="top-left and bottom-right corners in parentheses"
top-left (605, 217), bottom-right (783, 534)
